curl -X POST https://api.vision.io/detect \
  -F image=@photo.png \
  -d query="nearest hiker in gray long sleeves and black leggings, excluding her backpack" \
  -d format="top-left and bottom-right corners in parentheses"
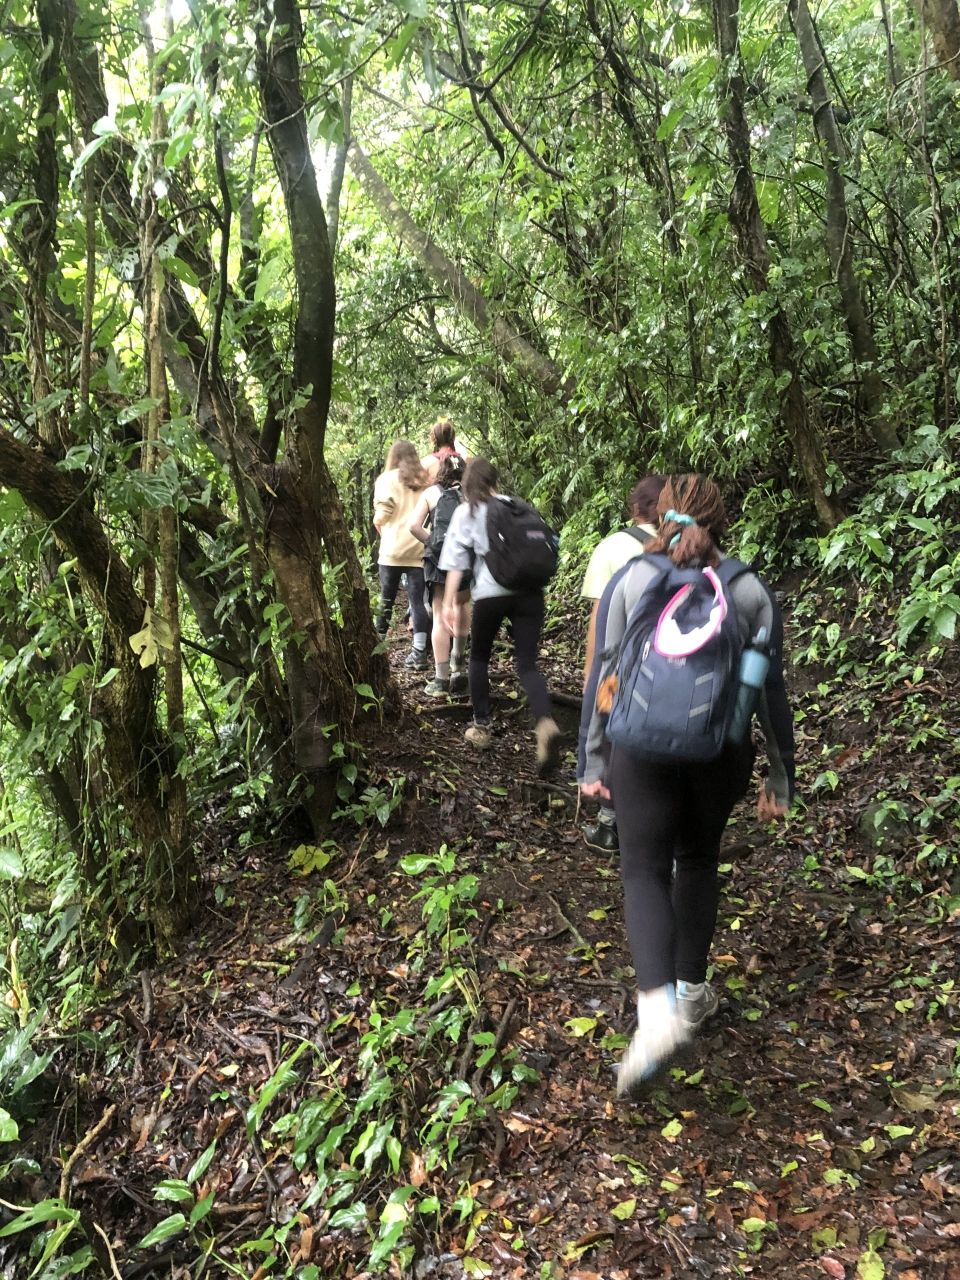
top-left (577, 475), bottom-right (794, 1093)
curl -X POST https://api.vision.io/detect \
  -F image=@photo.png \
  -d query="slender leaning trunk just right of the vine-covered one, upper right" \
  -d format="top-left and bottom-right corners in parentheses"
top-left (788, 0), bottom-right (900, 453)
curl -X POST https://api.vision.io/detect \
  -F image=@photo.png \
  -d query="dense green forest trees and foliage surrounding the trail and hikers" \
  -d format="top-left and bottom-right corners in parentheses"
top-left (0, 0), bottom-right (960, 1274)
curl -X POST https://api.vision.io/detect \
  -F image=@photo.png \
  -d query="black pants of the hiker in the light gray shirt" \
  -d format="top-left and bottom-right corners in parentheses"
top-left (470, 591), bottom-right (553, 721)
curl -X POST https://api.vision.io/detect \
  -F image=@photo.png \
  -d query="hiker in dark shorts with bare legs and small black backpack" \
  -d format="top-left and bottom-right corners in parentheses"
top-left (410, 452), bottom-right (470, 698)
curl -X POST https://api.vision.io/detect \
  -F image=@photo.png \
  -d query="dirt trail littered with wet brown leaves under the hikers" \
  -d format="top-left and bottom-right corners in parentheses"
top-left (0, 632), bottom-right (960, 1280)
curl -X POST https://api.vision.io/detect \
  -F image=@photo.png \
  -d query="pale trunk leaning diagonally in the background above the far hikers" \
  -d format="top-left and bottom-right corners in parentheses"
top-left (349, 142), bottom-right (573, 401)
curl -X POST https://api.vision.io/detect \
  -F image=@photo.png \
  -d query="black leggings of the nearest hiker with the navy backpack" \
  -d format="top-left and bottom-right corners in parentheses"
top-left (609, 744), bottom-right (754, 991)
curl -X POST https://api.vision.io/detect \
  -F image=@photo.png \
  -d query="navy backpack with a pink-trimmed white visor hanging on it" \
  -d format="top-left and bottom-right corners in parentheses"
top-left (598, 553), bottom-right (750, 762)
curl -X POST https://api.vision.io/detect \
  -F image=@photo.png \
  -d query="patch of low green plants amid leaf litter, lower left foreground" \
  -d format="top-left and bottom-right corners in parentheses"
top-left (0, 845), bottom-right (538, 1280)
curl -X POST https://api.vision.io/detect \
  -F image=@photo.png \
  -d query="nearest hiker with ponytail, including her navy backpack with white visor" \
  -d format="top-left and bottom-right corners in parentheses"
top-left (577, 475), bottom-right (794, 1094)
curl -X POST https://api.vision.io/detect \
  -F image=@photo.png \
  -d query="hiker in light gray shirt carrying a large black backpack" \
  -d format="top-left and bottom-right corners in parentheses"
top-left (440, 458), bottom-right (561, 774)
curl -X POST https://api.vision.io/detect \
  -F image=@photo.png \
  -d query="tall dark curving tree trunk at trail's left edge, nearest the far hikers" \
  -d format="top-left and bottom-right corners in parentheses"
top-left (256, 0), bottom-right (388, 828)
